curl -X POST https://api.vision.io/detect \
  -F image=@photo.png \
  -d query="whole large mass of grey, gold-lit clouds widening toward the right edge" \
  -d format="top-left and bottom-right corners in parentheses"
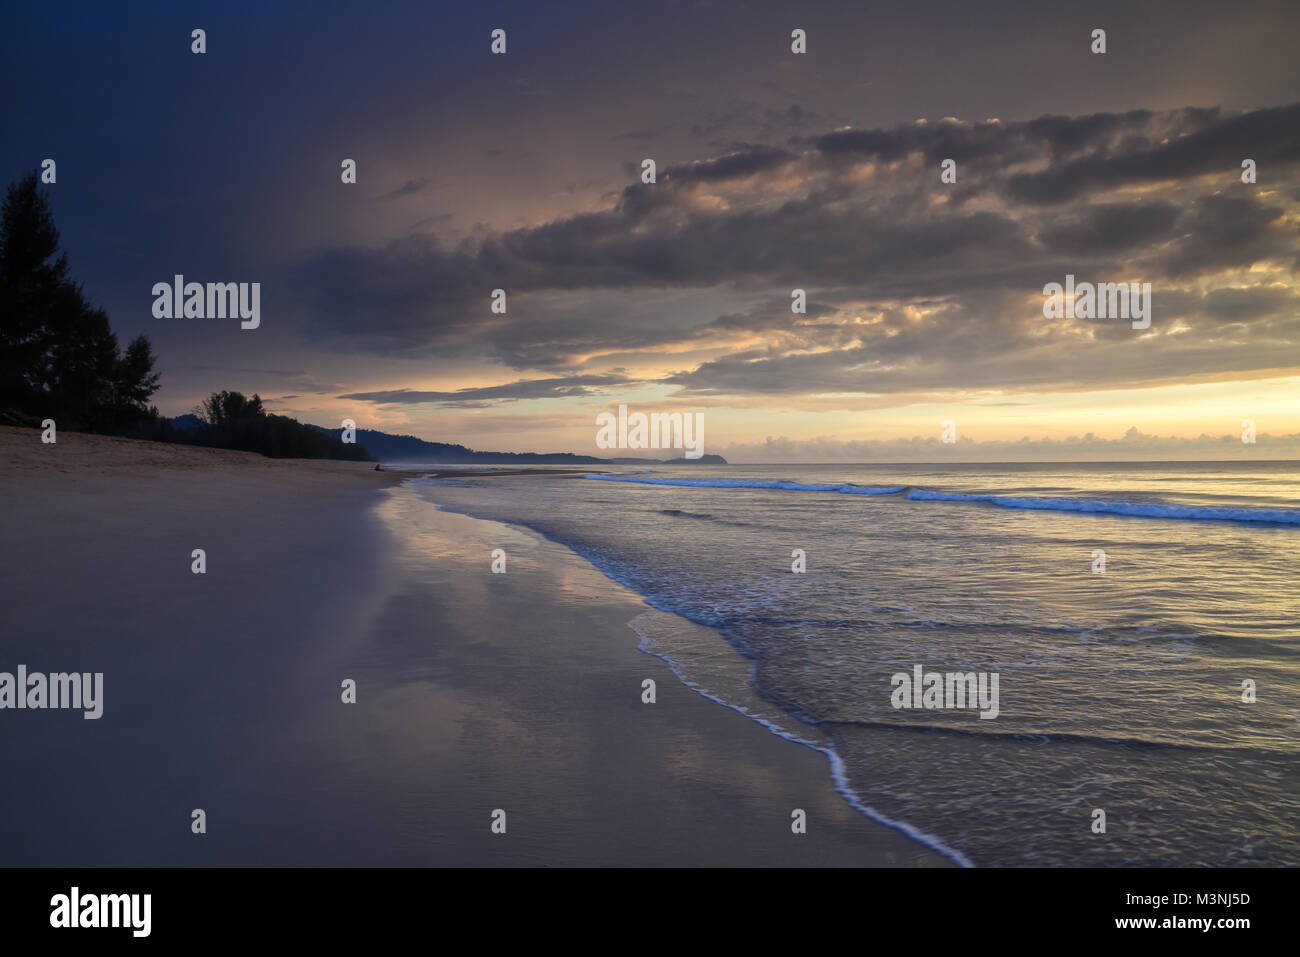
top-left (299, 104), bottom-right (1300, 390)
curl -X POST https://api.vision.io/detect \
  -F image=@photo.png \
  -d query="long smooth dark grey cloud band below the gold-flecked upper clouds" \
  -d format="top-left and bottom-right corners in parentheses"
top-left (299, 182), bottom-right (1031, 310)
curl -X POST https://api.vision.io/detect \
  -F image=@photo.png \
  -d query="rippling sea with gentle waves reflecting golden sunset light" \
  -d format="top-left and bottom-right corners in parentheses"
top-left (402, 462), bottom-right (1300, 866)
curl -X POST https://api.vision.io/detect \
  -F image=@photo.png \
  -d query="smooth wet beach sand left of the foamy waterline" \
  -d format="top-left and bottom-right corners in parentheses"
top-left (0, 428), bottom-right (948, 866)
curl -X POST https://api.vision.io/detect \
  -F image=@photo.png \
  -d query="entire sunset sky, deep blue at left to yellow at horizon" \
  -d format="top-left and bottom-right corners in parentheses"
top-left (0, 0), bottom-right (1300, 462)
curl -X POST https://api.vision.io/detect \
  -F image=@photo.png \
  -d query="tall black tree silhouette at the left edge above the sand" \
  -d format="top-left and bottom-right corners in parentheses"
top-left (0, 173), bottom-right (159, 432)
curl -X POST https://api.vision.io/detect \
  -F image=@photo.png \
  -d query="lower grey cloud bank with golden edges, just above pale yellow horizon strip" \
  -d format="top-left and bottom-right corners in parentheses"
top-left (668, 263), bottom-right (1300, 399)
